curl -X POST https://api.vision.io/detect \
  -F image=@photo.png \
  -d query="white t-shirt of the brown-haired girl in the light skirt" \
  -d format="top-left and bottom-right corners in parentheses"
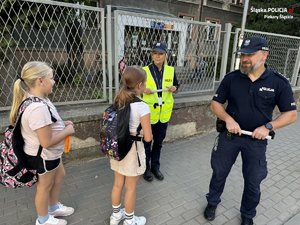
top-left (129, 102), bottom-right (150, 134)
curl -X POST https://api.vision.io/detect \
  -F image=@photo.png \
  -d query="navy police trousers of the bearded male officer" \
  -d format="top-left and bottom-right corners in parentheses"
top-left (206, 132), bottom-right (268, 218)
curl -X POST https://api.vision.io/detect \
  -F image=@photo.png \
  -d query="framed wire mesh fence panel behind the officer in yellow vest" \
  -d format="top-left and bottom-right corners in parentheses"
top-left (112, 10), bottom-right (221, 95)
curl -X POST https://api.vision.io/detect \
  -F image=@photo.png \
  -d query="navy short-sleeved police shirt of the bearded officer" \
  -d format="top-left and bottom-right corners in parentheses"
top-left (213, 68), bottom-right (296, 131)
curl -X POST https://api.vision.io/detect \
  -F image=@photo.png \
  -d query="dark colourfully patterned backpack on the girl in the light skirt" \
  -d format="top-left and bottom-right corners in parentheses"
top-left (100, 97), bottom-right (142, 164)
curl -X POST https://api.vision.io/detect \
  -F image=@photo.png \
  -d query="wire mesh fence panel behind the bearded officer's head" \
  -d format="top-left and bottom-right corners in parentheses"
top-left (231, 29), bottom-right (300, 86)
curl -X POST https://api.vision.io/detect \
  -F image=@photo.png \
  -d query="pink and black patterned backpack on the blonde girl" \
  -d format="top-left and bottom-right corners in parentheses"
top-left (0, 97), bottom-right (56, 188)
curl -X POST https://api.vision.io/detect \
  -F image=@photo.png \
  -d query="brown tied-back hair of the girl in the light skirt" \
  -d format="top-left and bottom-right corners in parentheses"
top-left (114, 66), bottom-right (146, 109)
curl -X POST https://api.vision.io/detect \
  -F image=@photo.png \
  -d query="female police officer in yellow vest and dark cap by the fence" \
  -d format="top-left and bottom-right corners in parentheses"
top-left (143, 42), bottom-right (179, 182)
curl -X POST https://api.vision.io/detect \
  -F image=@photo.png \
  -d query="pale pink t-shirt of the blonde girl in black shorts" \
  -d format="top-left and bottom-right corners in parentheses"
top-left (21, 99), bottom-right (65, 160)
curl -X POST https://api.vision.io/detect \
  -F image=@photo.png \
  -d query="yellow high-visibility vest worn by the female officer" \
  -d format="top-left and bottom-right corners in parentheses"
top-left (142, 65), bottom-right (174, 124)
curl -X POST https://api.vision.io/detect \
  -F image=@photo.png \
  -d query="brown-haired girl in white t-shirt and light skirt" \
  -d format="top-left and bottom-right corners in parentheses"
top-left (110, 66), bottom-right (152, 225)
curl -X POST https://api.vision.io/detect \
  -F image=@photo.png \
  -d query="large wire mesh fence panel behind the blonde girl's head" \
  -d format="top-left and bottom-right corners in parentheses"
top-left (0, 0), bottom-right (107, 109)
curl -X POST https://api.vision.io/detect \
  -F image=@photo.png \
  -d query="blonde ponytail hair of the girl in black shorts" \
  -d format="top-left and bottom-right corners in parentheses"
top-left (9, 61), bottom-right (52, 125)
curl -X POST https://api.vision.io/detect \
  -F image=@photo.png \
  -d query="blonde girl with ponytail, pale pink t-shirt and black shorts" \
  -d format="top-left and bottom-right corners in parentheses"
top-left (10, 61), bottom-right (75, 225)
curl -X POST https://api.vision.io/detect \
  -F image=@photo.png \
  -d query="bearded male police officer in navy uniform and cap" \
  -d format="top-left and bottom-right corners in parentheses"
top-left (204, 36), bottom-right (297, 225)
